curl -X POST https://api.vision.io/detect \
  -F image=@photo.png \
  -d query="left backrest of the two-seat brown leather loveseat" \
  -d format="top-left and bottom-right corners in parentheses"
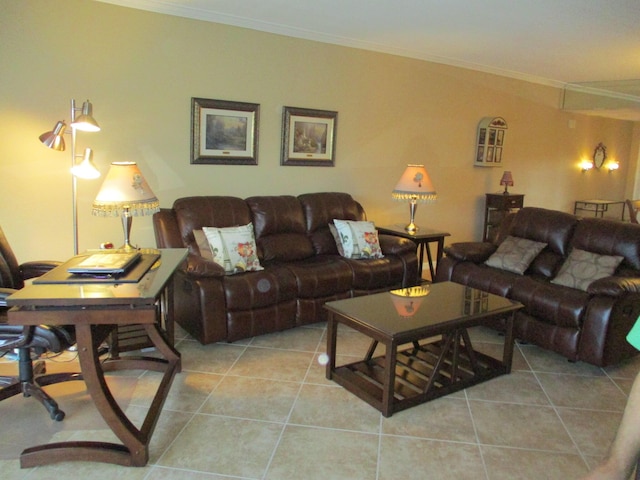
top-left (508, 207), bottom-right (579, 278)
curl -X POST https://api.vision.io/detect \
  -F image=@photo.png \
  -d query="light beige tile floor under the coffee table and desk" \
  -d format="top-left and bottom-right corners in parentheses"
top-left (0, 324), bottom-right (640, 480)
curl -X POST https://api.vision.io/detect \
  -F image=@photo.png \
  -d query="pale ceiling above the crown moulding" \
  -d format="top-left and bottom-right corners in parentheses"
top-left (98, 0), bottom-right (640, 120)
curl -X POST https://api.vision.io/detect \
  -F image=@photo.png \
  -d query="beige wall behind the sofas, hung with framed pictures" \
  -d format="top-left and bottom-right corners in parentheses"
top-left (0, 0), bottom-right (640, 261)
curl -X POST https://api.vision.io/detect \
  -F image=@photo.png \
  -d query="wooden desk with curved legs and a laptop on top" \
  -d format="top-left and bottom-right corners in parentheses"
top-left (7, 249), bottom-right (187, 468)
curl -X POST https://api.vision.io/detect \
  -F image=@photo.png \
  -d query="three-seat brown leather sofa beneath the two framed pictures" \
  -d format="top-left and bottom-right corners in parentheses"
top-left (153, 192), bottom-right (418, 344)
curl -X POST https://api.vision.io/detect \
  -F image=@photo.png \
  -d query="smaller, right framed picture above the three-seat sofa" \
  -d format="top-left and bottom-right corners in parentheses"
top-left (280, 107), bottom-right (338, 167)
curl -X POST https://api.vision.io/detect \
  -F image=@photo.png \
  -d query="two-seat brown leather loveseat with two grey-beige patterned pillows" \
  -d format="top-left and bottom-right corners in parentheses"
top-left (436, 207), bottom-right (640, 367)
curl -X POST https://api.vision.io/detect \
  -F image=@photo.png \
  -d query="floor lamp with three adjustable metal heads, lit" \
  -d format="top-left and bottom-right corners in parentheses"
top-left (40, 99), bottom-right (100, 255)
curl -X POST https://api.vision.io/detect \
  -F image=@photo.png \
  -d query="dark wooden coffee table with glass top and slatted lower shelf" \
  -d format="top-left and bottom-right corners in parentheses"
top-left (325, 282), bottom-right (522, 417)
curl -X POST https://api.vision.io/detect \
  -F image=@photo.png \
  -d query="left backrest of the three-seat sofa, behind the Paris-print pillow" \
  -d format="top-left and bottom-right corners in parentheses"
top-left (173, 196), bottom-right (251, 253)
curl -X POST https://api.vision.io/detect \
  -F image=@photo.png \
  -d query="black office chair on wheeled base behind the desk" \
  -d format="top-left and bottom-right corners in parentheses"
top-left (0, 228), bottom-right (82, 421)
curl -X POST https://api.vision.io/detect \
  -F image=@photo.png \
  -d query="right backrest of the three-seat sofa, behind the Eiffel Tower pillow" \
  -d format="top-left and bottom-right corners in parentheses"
top-left (298, 192), bottom-right (366, 255)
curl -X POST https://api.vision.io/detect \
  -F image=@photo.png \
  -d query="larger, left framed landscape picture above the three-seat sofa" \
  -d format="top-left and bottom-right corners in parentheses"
top-left (191, 98), bottom-right (260, 165)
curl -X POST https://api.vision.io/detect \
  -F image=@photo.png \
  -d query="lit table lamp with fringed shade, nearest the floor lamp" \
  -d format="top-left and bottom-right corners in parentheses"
top-left (91, 162), bottom-right (160, 250)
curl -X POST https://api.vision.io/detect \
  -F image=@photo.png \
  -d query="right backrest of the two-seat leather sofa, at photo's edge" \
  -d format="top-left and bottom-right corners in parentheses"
top-left (571, 217), bottom-right (640, 270)
